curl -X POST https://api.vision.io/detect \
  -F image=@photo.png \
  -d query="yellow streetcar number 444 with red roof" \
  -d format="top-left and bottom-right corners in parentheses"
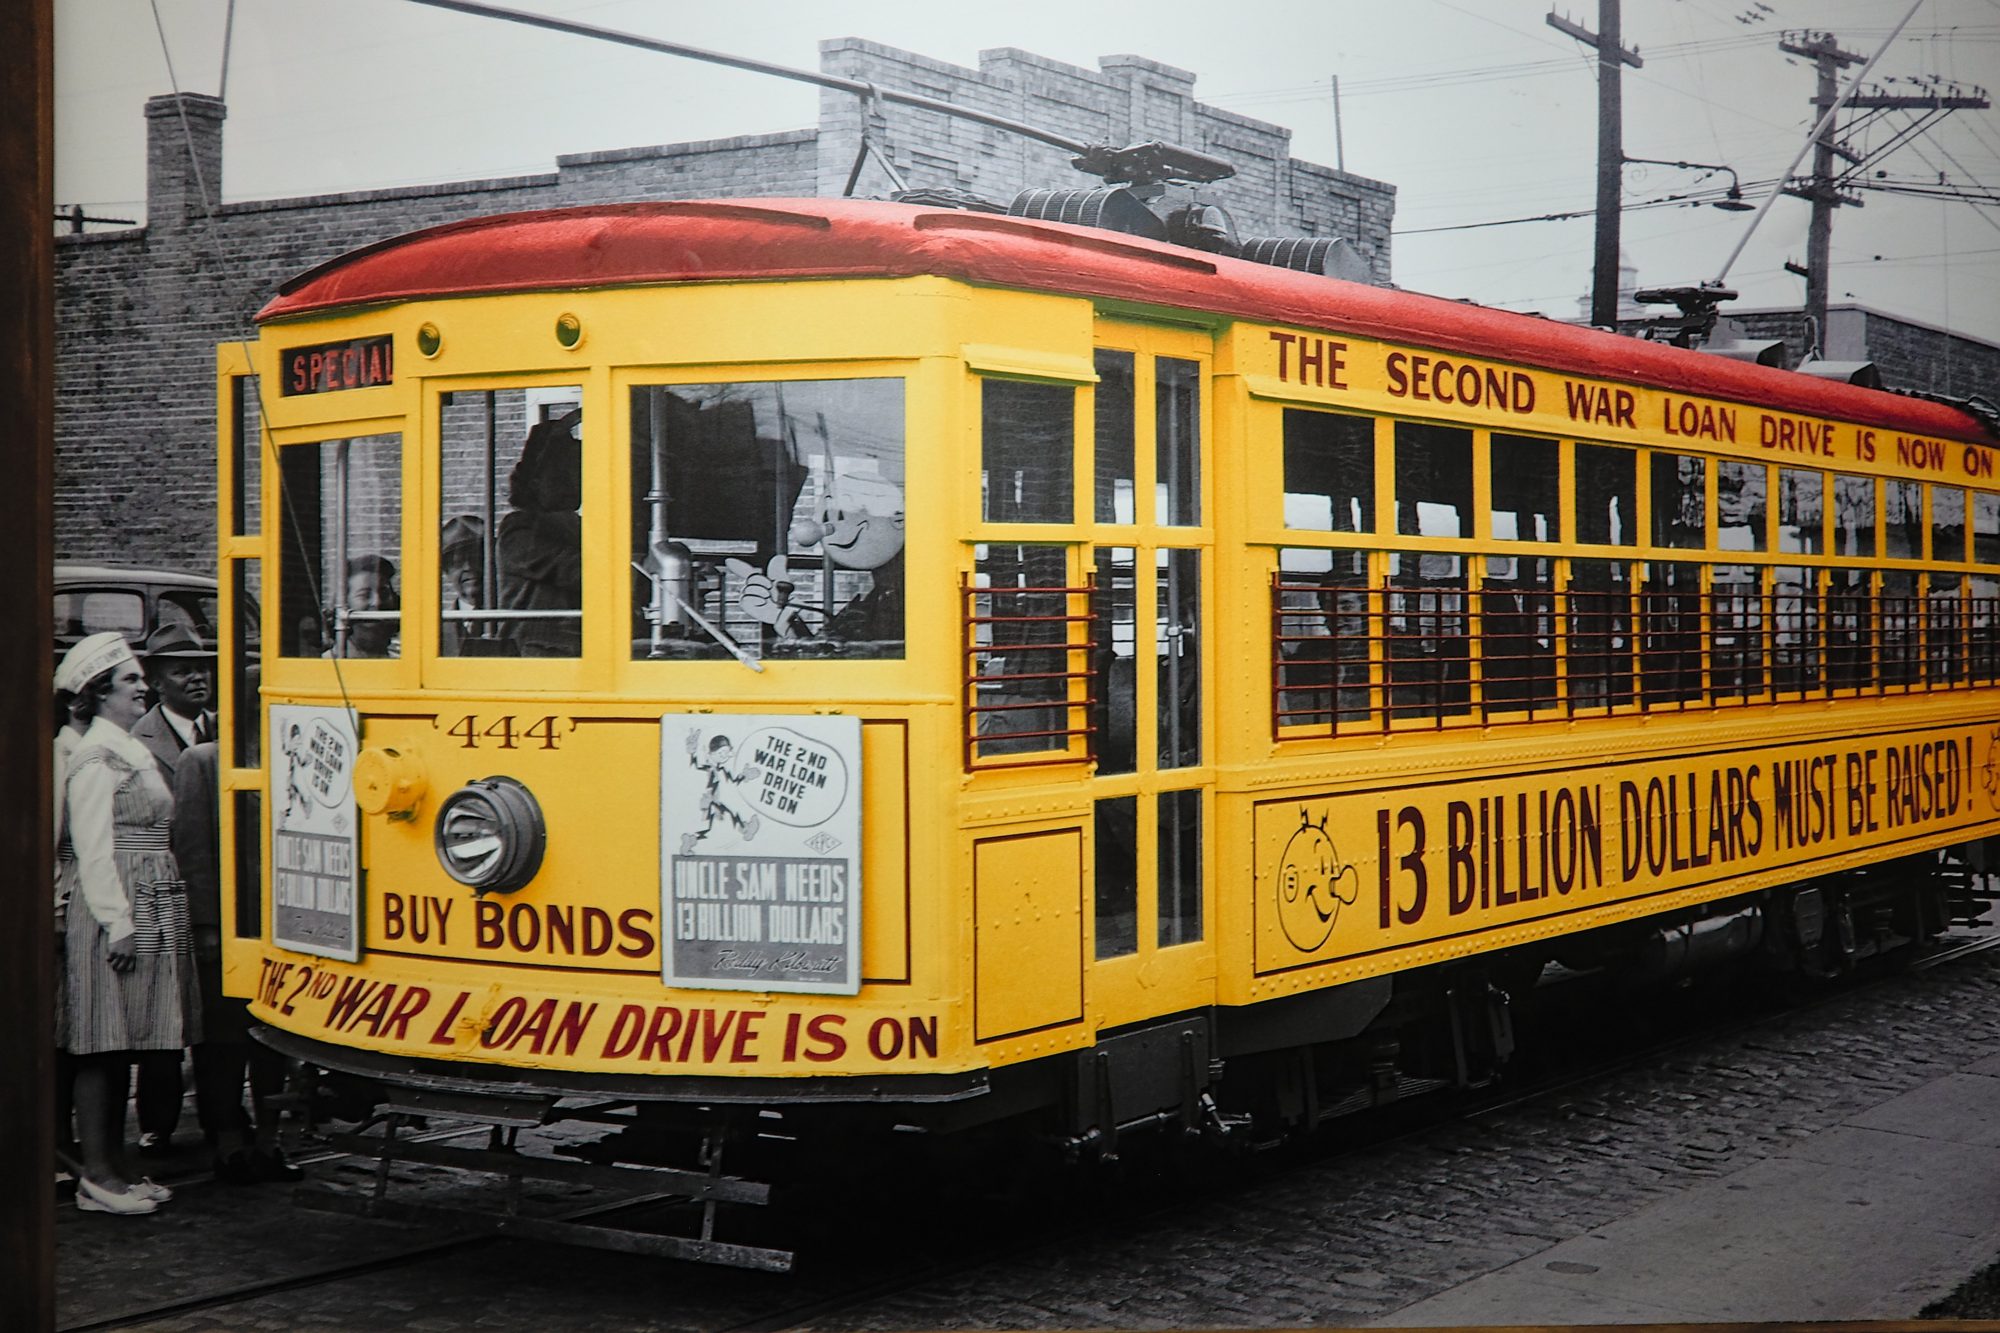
top-left (218, 200), bottom-right (2000, 1263)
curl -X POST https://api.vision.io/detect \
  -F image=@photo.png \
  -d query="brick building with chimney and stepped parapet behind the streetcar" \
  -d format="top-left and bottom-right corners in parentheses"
top-left (56, 38), bottom-right (1396, 570)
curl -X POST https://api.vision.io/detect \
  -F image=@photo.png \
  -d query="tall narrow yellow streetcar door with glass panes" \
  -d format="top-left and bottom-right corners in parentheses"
top-left (1084, 320), bottom-right (1214, 1029)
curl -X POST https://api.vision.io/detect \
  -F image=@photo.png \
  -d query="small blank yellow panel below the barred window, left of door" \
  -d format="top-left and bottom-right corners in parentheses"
top-left (972, 829), bottom-right (1084, 1041)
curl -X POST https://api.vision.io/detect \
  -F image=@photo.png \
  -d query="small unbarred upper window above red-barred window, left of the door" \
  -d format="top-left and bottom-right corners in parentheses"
top-left (980, 380), bottom-right (1076, 522)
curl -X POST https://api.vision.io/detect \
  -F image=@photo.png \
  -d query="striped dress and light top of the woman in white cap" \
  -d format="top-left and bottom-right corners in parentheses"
top-left (56, 739), bottom-right (202, 1055)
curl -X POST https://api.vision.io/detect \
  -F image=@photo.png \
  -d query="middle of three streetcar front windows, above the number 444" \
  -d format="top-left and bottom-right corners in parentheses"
top-left (436, 384), bottom-right (584, 656)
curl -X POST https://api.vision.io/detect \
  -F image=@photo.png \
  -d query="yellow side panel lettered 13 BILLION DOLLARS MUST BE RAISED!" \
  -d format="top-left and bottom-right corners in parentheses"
top-left (1244, 707), bottom-right (2000, 999)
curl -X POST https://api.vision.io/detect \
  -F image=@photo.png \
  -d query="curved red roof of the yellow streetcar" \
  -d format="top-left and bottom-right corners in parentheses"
top-left (258, 198), bottom-right (1992, 444)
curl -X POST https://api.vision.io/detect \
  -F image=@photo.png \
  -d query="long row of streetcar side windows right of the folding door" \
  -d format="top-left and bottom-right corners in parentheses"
top-left (1272, 408), bottom-right (2000, 737)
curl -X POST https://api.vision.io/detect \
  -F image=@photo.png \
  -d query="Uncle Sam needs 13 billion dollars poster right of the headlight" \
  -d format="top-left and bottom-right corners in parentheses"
top-left (660, 713), bottom-right (862, 995)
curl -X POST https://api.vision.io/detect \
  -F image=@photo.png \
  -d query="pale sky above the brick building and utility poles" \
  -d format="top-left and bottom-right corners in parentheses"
top-left (56, 0), bottom-right (2000, 342)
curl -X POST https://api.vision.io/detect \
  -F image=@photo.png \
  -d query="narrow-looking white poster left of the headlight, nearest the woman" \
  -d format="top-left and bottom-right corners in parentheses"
top-left (266, 705), bottom-right (362, 963)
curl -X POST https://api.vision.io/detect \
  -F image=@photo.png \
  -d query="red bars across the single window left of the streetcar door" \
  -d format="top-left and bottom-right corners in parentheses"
top-left (958, 576), bottom-right (1098, 773)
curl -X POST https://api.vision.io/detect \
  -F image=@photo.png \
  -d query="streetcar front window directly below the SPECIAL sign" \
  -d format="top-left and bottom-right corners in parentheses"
top-left (278, 434), bottom-right (402, 658)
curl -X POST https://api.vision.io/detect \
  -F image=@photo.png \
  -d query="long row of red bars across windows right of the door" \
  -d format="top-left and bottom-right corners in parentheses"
top-left (1270, 562), bottom-right (2000, 739)
